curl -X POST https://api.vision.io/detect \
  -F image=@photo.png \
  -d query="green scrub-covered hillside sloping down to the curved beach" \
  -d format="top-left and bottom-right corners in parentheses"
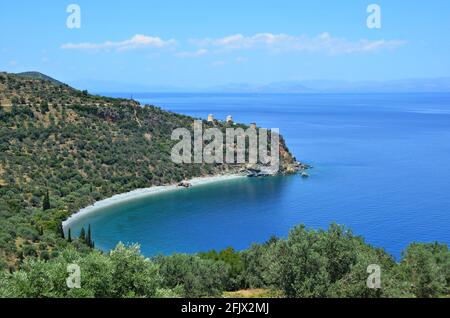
top-left (0, 73), bottom-right (300, 264)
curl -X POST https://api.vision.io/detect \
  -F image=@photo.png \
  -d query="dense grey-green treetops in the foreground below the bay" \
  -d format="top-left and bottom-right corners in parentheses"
top-left (0, 225), bottom-right (450, 297)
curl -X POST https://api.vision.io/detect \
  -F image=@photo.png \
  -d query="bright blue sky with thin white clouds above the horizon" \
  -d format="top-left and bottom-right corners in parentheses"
top-left (0, 0), bottom-right (450, 87)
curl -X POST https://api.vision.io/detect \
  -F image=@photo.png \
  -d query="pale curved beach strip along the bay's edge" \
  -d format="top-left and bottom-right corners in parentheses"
top-left (62, 174), bottom-right (246, 231)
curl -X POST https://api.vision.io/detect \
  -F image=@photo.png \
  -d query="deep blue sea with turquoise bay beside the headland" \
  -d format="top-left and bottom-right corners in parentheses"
top-left (67, 93), bottom-right (450, 258)
